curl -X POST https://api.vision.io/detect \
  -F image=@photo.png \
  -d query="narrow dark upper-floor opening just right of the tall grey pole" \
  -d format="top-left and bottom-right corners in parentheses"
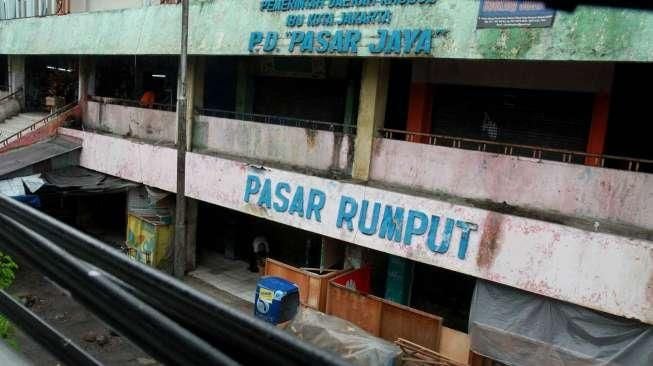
top-left (204, 57), bottom-right (238, 111)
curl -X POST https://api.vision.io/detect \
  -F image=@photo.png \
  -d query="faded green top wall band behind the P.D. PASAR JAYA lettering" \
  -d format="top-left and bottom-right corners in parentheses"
top-left (0, 0), bottom-right (653, 61)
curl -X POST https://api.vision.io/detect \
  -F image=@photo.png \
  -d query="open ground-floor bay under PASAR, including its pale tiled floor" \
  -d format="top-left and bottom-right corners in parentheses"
top-left (190, 202), bottom-right (332, 302)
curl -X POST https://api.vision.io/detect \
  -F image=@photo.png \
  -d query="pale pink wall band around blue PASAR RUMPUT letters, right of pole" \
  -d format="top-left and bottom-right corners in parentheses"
top-left (186, 153), bottom-right (653, 323)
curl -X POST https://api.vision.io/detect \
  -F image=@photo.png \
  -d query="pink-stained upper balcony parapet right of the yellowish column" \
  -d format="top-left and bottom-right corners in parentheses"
top-left (371, 138), bottom-right (653, 230)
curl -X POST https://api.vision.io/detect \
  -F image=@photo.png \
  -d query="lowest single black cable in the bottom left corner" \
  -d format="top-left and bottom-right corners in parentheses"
top-left (0, 290), bottom-right (102, 366)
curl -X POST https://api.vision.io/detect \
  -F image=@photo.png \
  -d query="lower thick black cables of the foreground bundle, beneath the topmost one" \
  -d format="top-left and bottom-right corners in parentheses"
top-left (0, 214), bottom-right (238, 365)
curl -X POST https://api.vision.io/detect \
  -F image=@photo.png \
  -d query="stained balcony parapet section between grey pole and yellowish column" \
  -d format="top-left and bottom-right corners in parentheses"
top-left (193, 116), bottom-right (352, 172)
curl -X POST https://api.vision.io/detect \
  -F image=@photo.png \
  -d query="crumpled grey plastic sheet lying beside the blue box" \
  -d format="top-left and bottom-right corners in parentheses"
top-left (286, 308), bottom-right (401, 366)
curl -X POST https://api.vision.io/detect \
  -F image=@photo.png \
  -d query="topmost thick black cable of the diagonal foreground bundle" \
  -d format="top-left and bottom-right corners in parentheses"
top-left (0, 196), bottom-right (347, 365)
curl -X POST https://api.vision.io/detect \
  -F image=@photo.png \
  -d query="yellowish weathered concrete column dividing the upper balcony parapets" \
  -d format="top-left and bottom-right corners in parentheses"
top-left (351, 59), bottom-right (390, 181)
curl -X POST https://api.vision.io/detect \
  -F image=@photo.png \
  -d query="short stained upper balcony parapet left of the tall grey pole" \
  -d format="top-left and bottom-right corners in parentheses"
top-left (84, 101), bottom-right (177, 143)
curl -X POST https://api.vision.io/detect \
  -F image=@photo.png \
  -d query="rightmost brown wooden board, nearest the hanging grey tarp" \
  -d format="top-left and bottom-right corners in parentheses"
top-left (379, 299), bottom-right (442, 351)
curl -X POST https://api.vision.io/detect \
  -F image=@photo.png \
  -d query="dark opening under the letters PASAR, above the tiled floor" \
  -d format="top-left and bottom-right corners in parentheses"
top-left (197, 202), bottom-right (322, 268)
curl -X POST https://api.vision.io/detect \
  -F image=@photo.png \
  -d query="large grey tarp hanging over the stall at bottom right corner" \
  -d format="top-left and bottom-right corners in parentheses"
top-left (469, 280), bottom-right (653, 366)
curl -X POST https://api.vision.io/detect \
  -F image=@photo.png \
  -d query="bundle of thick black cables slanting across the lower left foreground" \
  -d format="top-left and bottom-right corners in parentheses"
top-left (0, 195), bottom-right (347, 366)
